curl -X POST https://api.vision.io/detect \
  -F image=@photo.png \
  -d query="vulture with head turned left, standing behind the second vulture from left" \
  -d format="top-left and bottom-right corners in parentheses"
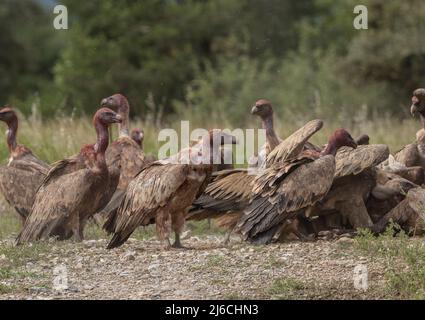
top-left (95, 94), bottom-right (145, 219)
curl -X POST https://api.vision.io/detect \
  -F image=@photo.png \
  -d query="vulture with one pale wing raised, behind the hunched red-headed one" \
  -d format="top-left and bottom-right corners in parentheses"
top-left (187, 117), bottom-right (323, 243)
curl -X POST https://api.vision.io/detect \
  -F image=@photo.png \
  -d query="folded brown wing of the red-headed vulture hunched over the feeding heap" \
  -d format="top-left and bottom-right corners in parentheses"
top-left (238, 156), bottom-right (335, 238)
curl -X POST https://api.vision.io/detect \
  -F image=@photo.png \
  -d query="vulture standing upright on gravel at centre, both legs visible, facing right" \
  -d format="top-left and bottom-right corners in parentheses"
top-left (108, 130), bottom-right (236, 249)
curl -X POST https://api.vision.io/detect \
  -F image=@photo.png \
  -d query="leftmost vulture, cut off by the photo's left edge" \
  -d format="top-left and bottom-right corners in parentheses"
top-left (0, 107), bottom-right (49, 224)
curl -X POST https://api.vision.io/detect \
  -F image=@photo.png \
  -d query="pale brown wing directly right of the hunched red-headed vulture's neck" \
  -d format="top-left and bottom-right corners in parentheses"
top-left (335, 144), bottom-right (390, 179)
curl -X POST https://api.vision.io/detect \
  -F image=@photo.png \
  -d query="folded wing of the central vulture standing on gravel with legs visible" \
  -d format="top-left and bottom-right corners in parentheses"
top-left (108, 163), bottom-right (189, 248)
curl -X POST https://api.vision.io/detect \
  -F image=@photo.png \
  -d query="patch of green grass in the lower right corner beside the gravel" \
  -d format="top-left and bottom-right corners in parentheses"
top-left (356, 226), bottom-right (425, 300)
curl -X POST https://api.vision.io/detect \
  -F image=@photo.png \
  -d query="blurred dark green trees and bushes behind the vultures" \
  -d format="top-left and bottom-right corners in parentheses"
top-left (0, 0), bottom-right (425, 126)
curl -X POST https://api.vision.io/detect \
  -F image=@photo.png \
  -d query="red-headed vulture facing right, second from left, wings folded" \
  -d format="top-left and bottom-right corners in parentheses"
top-left (17, 108), bottom-right (122, 244)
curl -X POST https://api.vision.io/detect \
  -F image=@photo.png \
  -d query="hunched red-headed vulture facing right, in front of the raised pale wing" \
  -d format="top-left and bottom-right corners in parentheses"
top-left (237, 129), bottom-right (357, 243)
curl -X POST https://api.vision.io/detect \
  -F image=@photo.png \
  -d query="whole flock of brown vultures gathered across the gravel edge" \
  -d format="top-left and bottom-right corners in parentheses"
top-left (0, 89), bottom-right (425, 249)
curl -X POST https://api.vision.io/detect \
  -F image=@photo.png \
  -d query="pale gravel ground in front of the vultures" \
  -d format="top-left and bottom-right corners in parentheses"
top-left (0, 232), bottom-right (385, 299)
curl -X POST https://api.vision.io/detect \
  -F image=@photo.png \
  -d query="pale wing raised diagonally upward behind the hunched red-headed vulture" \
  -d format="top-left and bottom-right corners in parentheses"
top-left (266, 119), bottom-right (323, 166)
